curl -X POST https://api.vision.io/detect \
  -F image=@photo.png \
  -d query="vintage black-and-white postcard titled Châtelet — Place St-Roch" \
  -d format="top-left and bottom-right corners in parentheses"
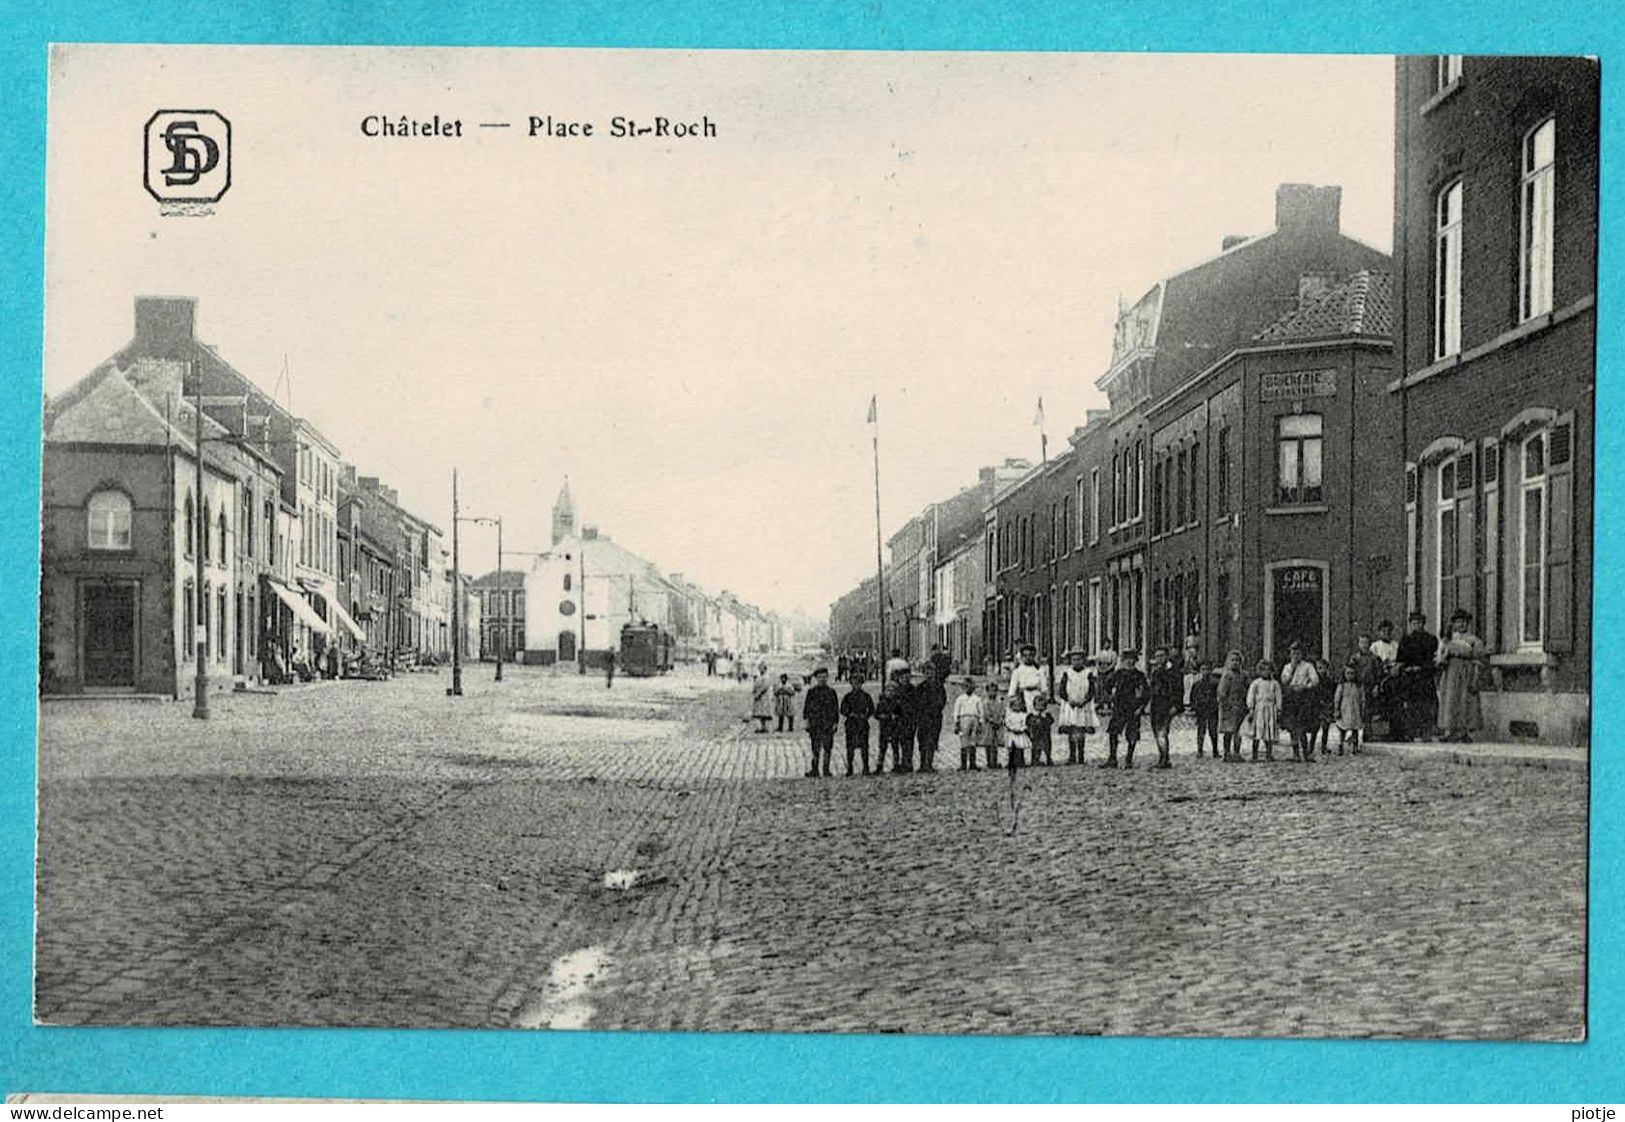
top-left (34, 44), bottom-right (1599, 1041)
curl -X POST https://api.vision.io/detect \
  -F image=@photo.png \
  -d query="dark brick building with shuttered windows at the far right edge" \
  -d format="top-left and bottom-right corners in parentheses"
top-left (1391, 55), bottom-right (1599, 743)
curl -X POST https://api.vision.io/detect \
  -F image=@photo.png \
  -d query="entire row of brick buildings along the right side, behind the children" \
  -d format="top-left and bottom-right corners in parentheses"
top-left (830, 55), bottom-right (1597, 741)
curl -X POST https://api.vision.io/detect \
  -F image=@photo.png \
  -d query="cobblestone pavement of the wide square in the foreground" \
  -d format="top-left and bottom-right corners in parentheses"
top-left (36, 667), bottom-right (1586, 1039)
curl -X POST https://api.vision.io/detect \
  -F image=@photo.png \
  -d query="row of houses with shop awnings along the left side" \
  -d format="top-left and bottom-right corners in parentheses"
top-left (41, 296), bottom-right (478, 696)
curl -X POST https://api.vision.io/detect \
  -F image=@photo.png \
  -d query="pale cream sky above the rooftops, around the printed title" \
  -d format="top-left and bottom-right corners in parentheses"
top-left (44, 44), bottom-right (1393, 618)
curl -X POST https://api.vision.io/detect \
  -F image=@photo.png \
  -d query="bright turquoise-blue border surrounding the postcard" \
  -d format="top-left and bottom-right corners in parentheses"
top-left (0, 0), bottom-right (1625, 1102)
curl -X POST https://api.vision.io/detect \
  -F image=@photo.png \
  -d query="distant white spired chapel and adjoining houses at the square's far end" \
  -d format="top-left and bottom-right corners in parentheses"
top-left (473, 480), bottom-right (796, 665)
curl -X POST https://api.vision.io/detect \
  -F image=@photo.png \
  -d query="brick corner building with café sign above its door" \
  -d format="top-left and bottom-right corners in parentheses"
top-left (1147, 270), bottom-right (1402, 662)
